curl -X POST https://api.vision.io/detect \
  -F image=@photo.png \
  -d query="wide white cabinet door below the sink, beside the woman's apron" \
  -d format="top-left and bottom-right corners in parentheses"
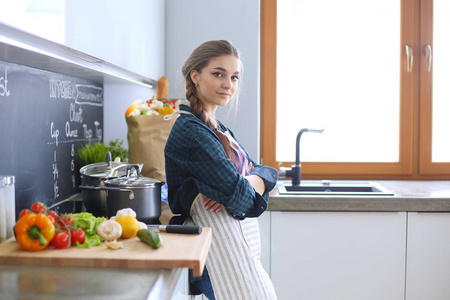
top-left (271, 212), bottom-right (406, 300)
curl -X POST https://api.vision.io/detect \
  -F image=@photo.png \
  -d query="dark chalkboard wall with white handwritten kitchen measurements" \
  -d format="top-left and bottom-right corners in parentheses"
top-left (0, 61), bottom-right (103, 216)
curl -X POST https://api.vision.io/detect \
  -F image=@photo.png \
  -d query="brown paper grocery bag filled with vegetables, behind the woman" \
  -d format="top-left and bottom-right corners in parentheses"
top-left (126, 115), bottom-right (177, 182)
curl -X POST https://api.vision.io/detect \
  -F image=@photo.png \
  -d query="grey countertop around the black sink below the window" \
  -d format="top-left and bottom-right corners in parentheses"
top-left (268, 180), bottom-right (450, 212)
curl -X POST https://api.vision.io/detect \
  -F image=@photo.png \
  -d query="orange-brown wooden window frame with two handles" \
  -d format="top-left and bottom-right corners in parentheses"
top-left (260, 0), bottom-right (450, 179)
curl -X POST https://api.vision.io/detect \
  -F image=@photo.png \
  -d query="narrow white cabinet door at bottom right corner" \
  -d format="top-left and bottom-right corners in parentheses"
top-left (406, 213), bottom-right (450, 300)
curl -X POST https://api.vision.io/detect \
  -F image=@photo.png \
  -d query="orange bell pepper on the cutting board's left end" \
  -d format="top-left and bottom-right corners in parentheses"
top-left (14, 213), bottom-right (55, 251)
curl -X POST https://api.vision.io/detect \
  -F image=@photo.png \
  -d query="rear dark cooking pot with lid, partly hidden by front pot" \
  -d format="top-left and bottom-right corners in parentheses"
top-left (80, 160), bottom-right (137, 217)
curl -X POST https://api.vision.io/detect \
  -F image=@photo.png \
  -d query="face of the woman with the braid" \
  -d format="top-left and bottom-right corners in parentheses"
top-left (191, 55), bottom-right (240, 115)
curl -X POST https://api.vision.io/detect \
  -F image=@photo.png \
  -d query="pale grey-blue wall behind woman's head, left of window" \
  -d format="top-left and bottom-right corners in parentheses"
top-left (165, 0), bottom-right (260, 161)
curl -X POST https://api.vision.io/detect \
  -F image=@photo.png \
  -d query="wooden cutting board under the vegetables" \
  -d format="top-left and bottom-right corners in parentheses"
top-left (0, 227), bottom-right (212, 276)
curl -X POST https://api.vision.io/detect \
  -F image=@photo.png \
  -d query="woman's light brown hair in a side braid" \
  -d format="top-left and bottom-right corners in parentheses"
top-left (181, 40), bottom-right (242, 129)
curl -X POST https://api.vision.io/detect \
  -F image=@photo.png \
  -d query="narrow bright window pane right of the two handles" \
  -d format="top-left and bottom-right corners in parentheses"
top-left (432, 0), bottom-right (450, 162)
